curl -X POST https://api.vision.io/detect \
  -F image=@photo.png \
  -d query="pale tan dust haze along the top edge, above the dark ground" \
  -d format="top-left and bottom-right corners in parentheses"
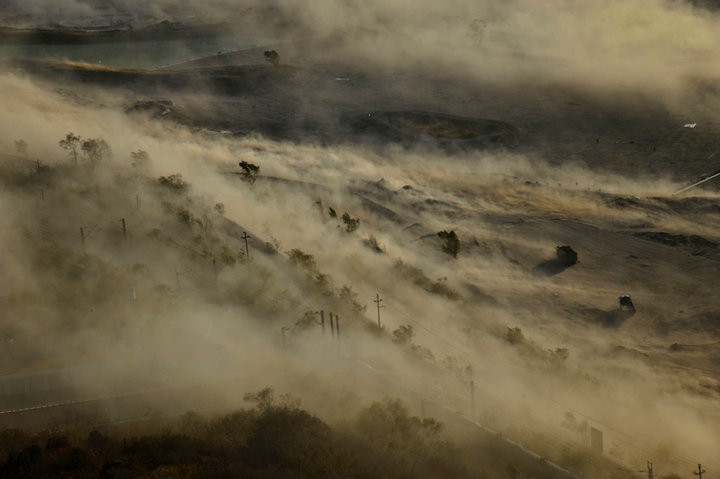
top-left (6, 0), bottom-right (720, 106)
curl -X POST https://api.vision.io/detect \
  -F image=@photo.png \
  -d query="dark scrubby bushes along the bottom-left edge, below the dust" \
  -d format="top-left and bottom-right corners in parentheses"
top-left (0, 388), bottom-right (478, 479)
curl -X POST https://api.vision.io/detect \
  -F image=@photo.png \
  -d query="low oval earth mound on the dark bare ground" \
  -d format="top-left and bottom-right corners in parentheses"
top-left (342, 111), bottom-right (519, 148)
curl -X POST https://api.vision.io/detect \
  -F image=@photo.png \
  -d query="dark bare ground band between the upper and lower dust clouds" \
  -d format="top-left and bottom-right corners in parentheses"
top-left (17, 45), bottom-right (720, 182)
